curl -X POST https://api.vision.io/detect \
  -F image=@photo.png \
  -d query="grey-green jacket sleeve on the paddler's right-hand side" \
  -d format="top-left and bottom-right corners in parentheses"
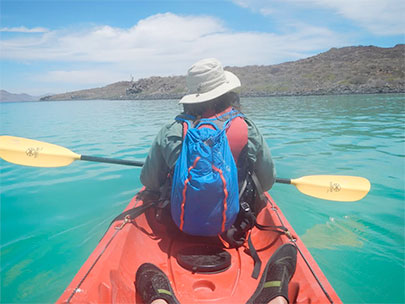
top-left (245, 119), bottom-right (276, 191)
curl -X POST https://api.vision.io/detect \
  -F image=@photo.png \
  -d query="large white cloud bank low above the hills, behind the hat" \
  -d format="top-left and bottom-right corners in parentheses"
top-left (0, 13), bottom-right (350, 92)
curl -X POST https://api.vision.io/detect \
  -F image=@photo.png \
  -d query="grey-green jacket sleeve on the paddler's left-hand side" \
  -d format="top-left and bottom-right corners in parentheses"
top-left (140, 122), bottom-right (183, 192)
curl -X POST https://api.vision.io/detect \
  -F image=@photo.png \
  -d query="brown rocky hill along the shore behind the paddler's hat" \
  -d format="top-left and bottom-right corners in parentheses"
top-left (41, 44), bottom-right (405, 100)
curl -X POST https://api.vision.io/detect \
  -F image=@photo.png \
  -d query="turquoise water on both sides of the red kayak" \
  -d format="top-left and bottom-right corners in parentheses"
top-left (0, 95), bottom-right (405, 303)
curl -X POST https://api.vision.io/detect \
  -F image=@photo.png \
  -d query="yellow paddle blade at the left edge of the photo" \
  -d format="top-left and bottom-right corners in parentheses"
top-left (0, 135), bottom-right (80, 167)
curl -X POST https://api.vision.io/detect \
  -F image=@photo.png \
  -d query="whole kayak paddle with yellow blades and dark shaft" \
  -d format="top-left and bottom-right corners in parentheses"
top-left (0, 135), bottom-right (370, 202)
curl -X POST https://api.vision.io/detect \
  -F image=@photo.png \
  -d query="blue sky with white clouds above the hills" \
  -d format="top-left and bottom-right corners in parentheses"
top-left (0, 0), bottom-right (405, 96)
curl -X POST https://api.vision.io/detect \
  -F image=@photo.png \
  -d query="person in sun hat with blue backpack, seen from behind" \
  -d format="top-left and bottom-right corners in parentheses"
top-left (140, 58), bottom-right (276, 238)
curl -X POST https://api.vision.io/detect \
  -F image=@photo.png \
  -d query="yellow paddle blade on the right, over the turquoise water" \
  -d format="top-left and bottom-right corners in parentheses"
top-left (291, 175), bottom-right (371, 202)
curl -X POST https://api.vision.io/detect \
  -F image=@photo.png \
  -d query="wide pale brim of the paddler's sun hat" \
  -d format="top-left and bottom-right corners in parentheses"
top-left (179, 71), bottom-right (241, 103)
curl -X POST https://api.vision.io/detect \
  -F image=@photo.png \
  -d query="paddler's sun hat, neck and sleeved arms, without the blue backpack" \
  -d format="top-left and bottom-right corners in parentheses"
top-left (141, 59), bottom-right (275, 203)
